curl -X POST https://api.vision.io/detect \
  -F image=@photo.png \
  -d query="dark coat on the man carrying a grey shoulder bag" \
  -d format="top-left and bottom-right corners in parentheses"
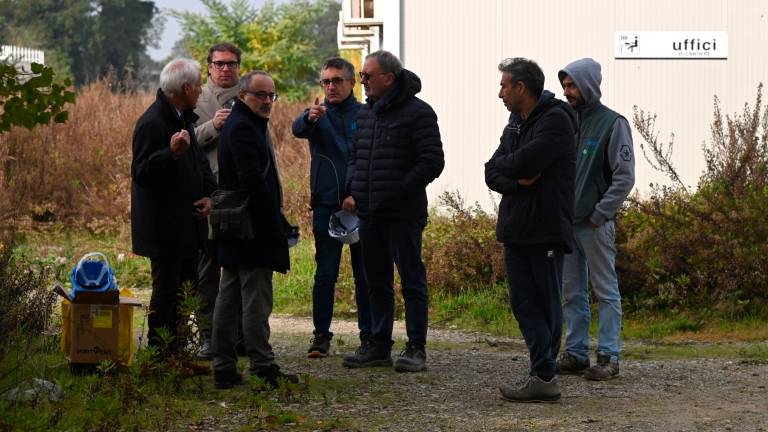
top-left (217, 100), bottom-right (290, 273)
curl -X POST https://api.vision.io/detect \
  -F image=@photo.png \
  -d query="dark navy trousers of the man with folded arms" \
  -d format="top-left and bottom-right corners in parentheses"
top-left (504, 244), bottom-right (563, 378)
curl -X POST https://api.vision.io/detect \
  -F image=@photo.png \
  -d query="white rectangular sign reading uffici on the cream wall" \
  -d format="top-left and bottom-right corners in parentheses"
top-left (614, 31), bottom-right (728, 60)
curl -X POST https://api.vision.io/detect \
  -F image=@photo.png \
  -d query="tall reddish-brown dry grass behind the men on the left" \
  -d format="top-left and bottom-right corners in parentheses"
top-left (0, 81), bottom-right (310, 233)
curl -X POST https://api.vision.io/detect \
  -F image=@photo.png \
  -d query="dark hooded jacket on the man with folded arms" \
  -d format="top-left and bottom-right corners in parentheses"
top-left (485, 93), bottom-right (576, 252)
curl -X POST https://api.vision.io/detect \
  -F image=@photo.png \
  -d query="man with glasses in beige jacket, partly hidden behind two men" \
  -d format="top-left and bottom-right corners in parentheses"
top-left (195, 42), bottom-right (242, 360)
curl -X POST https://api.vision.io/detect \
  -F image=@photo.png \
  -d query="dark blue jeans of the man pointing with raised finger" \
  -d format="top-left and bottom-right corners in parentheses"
top-left (312, 207), bottom-right (371, 337)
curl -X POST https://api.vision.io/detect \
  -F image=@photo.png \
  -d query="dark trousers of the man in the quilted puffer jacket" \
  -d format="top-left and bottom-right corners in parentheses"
top-left (360, 219), bottom-right (429, 347)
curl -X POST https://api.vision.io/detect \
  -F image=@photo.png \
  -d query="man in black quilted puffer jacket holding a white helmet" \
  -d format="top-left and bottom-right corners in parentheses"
top-left (342, 51), bottom-right (445, 372)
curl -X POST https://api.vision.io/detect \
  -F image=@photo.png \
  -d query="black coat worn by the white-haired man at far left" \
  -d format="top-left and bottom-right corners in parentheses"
top-left (131, 90), bottom-right (216, 259)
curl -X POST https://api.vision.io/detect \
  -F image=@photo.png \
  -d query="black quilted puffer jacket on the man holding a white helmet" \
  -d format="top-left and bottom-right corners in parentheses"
top-left (347, 69), bottom-right (445, 221)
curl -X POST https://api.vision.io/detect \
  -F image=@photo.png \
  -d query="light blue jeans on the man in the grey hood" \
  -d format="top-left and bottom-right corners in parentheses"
top-left (563, 221), bottom-right (621, 362)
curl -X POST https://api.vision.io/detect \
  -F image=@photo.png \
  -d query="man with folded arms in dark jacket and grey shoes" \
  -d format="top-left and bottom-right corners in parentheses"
top-left (485, 58), bottom-right (576, 402)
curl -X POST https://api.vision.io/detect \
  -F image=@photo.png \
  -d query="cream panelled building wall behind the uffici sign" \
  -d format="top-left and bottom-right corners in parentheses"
top-left (396, 0), bottom-right (768, 207)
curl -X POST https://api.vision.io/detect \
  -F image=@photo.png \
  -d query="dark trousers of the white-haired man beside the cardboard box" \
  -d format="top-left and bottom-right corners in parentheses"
top-left (147, 258), bottom-right (197, 346)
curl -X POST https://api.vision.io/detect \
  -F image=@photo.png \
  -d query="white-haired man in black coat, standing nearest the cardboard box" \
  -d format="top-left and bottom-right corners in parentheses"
top-left (131, 59), bottom-right (216, 352)
